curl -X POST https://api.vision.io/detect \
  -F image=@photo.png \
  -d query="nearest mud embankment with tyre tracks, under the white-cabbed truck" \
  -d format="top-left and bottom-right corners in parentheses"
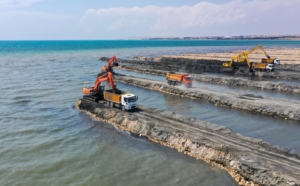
top-left (77, 100), bottom-right (300, 186)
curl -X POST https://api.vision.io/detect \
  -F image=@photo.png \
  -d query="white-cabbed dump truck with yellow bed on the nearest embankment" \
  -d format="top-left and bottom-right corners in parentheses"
top-left (103, 89), bottom-right (138, 111)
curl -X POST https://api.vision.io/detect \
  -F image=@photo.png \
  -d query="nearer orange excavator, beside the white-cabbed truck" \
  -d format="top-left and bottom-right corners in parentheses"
top-left (82, 72), bottom-right (117, 102)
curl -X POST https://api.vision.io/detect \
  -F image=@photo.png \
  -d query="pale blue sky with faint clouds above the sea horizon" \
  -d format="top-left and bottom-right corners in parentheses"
top-left (0, 0), bottom-right (300, 40)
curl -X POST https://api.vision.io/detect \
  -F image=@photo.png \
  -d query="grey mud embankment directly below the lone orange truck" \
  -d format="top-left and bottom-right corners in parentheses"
top-left (115, 76), bottom-right (300, 120)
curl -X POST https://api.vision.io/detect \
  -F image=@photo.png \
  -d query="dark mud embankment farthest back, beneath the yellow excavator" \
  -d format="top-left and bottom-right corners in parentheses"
top-left (99, 57), bottom-right (300, 80)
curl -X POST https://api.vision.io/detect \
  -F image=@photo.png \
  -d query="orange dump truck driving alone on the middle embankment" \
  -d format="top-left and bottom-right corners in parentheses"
top-left (166, 72), bottom-right (193, 88)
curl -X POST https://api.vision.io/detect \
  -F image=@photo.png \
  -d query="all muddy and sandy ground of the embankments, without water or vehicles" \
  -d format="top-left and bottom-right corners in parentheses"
top-left (77, 51), bottom-right (300, 185)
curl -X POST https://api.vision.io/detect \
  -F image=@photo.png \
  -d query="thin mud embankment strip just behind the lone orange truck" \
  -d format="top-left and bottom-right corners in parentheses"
top-left (118, 65), bottom-right (300, 94)
